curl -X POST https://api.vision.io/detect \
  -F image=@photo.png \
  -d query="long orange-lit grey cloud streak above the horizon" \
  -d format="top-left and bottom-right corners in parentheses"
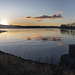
top-left (18, 12), bottom-right (63, 21)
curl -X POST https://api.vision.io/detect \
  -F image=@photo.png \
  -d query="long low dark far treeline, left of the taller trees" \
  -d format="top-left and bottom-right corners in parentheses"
top-left (0, 25), bottom-right (59, 28)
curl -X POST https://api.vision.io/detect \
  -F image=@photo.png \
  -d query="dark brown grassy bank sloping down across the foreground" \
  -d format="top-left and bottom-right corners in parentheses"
top-left (0, 51), bottom-right (74, 75)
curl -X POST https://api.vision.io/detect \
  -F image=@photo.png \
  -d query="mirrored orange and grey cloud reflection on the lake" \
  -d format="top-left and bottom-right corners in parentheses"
top-left (18, 35), bottom-right (63, 46)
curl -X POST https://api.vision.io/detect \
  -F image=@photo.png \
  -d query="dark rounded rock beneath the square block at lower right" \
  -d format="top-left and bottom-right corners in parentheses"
top-left (59, 54), bottom-right (75, 69)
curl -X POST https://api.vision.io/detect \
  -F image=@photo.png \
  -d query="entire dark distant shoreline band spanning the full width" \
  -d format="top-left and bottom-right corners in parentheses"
top-left (0, 25), bottom-right (75, 30)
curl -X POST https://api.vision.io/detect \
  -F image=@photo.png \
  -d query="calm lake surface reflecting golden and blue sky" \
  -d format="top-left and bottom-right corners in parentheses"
top-left (0, 28), bottom-right (75, 63)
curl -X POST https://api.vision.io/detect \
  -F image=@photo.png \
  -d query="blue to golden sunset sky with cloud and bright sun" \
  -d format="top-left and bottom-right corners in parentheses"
top-left (0, 0), bottom-right (75, 26)
